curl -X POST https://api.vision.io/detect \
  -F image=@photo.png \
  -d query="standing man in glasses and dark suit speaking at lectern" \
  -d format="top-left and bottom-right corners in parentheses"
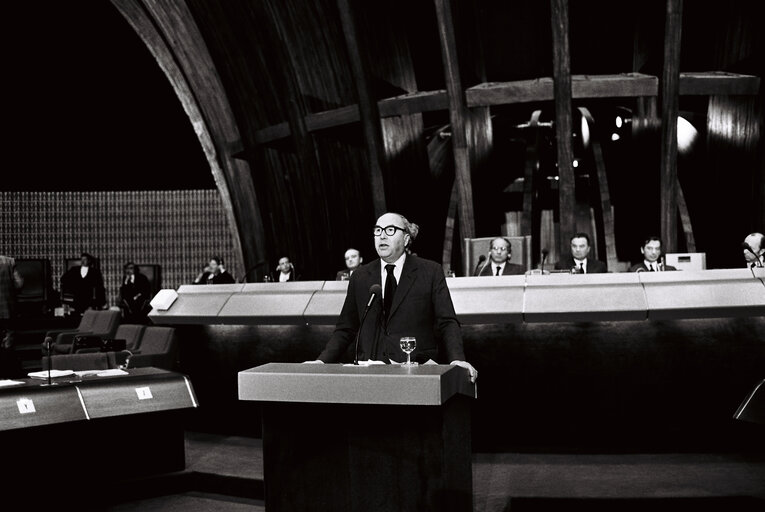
top-left (308, 213), bottom-right (478, 382)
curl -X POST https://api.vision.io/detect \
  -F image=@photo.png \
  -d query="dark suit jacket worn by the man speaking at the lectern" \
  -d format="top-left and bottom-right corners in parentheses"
top-left (318, 255), bottom-right (465, 364)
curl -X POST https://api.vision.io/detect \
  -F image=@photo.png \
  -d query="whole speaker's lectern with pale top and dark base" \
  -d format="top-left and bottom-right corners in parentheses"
top-left (239, 363), bottom-right (475, 512)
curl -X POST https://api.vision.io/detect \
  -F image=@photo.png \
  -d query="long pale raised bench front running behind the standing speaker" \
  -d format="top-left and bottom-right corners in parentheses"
top-left (149, 269), bottom-right (765, 325)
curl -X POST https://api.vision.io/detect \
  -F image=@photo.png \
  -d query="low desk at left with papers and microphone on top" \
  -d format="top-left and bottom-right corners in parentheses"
top-left (0, 368), bottom-right (198, 508)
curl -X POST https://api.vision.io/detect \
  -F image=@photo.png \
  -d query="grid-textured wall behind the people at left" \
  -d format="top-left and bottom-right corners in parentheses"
top-left (0, 190), bottom-right (240, 305)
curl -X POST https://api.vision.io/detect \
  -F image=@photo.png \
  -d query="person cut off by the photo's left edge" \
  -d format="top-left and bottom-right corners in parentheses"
top-left (0, 256), bottom-right (24, 378)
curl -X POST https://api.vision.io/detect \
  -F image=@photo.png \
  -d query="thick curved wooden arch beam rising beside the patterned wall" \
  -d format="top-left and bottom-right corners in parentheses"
top-left (112, 0), bottom-right (268, 280)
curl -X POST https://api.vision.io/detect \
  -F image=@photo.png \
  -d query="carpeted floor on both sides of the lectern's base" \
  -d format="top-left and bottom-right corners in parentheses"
top-left (105, 432), bottom-right (765, 512)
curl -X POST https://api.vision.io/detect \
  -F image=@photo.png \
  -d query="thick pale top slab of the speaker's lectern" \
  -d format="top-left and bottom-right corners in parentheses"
top-left (239, 363), bottom-right (476, 406)
